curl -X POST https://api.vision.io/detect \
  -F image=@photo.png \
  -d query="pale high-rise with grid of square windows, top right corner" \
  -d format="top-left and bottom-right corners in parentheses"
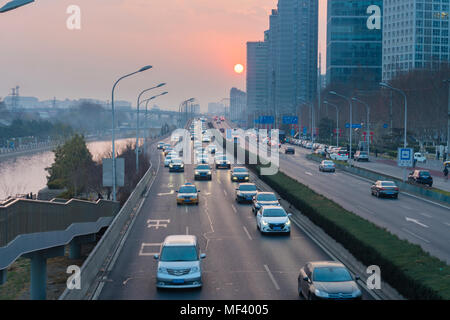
top-left (382, 0), bottom-right (449, 81)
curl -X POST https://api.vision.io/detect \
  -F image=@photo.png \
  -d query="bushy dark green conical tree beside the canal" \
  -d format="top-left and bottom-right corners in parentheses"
top-left (46, 134), bottom-right (101, 195)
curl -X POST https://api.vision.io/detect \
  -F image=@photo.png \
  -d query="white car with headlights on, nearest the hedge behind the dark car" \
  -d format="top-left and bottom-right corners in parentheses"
top-left (256, 206), bottom-right (292, 234)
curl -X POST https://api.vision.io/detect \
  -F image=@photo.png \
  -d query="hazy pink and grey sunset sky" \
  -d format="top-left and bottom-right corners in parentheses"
top-left (0, 0), bottom-right (326, 110)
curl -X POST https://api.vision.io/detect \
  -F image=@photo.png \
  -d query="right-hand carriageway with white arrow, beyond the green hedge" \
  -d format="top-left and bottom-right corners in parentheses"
top-left (220, 123), bottom-right (450, 263)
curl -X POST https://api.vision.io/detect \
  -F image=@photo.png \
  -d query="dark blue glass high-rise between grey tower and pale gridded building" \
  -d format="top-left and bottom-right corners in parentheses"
top-left (327, 0), bottom-right (382, 88)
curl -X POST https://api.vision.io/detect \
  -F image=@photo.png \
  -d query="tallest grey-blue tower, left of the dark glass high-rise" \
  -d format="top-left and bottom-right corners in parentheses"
top-left (267, 0), bottom-right (318, 119)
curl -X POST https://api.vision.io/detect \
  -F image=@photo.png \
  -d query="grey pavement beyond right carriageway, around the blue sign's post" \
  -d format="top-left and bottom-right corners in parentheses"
top-left (353, 156), bottom-right (450, 192)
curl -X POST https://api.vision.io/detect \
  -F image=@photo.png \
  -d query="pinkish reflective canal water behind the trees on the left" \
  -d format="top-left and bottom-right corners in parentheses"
top-left (0, 139), bottom-right (134, 200)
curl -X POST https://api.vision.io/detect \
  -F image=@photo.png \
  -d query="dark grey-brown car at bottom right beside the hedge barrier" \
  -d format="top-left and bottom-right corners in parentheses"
top-left (297, 261), bottom-right (362, 300)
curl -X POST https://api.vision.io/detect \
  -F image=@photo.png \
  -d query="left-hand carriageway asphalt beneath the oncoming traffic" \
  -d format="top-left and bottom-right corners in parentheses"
top-left (96, 138), bottom-right (370, 300)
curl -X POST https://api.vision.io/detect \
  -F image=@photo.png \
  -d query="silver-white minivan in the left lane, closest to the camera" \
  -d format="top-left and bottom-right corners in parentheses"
top-left (154, 235), bottom-right (206, 288)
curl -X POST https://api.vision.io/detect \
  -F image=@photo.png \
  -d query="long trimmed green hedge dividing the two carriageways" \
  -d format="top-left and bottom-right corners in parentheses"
top-left (235, 144), bottom-right (450, 300)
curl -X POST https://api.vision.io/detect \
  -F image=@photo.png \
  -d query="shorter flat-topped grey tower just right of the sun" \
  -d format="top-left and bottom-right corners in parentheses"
top-left (246, 41), bottom-right (268, 126)
